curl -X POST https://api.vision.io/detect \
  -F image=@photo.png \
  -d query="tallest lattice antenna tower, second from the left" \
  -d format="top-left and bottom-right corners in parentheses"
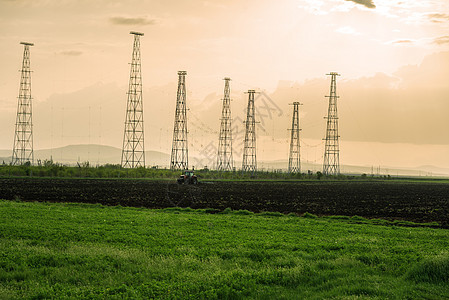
top-left (121, 31), bottom-right (145, 168)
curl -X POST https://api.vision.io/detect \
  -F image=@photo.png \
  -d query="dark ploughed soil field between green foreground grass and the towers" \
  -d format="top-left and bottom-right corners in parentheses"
top-left (0, 178), bottom-right (449, 227)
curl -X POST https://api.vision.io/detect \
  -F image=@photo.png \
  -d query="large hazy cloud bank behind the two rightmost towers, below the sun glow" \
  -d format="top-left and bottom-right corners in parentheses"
top-left (264, 51), bottom-right (449, 145)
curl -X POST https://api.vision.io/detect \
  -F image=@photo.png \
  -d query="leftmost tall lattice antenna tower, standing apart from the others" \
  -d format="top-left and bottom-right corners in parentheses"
top-left (12, 42), bottom-right (34, 165)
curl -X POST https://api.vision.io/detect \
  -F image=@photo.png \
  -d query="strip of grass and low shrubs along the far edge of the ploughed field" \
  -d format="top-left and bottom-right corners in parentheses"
top-left (5, 160), bottom-right (449, 183)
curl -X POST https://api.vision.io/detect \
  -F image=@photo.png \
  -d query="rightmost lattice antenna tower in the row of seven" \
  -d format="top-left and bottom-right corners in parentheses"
top-left (323, 72), bottom-right (340, 175)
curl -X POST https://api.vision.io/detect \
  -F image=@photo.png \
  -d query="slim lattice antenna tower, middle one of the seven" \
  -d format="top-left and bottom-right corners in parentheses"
top-left (217, 77), bottom-right (234, 171)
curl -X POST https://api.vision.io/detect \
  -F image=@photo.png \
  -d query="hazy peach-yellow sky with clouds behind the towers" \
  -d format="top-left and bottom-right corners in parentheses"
top-left (0, 0), bottom-right (449, 168)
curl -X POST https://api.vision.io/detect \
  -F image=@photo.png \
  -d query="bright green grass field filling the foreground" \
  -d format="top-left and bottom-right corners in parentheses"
top-left (0, 201), bottom-right (449, 299)
